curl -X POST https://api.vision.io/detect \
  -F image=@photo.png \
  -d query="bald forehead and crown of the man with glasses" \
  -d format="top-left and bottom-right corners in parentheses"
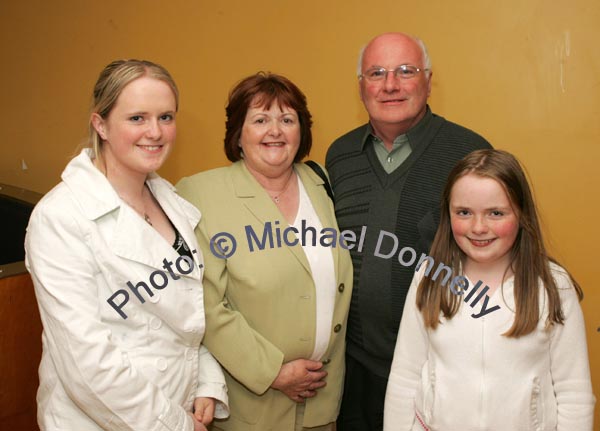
top-left (362, 33), bottom-right (425, 70)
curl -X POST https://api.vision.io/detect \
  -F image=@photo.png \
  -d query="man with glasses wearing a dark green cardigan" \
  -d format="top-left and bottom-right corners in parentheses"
top-left (326, 33), bottom-right (490, 431)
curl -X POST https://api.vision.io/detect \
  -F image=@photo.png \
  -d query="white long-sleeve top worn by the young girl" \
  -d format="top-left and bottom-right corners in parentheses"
top-left (384, 264), bottom-right (595, 431)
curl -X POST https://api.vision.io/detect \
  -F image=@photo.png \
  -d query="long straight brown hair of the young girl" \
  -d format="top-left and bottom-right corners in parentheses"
top-left (417, 150), bottom-right (583, 338)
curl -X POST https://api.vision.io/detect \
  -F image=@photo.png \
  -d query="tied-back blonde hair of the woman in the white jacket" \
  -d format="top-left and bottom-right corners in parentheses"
top-left (88, 59), bottom-right (179, 160)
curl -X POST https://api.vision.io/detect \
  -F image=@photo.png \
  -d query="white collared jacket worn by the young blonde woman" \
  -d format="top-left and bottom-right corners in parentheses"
top-left (25, 150), bottom-right (228, 431)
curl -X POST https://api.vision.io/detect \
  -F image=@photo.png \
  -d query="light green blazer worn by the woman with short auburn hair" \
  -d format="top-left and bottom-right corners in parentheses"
top-left (177, 161), bottom-right (352, 431)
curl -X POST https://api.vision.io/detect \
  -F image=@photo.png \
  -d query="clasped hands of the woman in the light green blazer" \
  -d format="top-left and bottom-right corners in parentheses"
top-left (271, 359), bottom-right (327, 403)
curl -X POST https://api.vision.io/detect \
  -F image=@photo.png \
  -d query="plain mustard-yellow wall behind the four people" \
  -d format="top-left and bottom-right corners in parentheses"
top-left (0, 0), bottom-right (600, 430)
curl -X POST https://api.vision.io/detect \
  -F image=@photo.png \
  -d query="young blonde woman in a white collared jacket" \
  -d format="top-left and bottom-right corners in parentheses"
top-left (26, 60), bottom-right (228, 431)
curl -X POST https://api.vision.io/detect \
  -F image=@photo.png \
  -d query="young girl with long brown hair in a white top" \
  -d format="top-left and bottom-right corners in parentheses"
top-left (384, 150), bottom-right (595, 431)
